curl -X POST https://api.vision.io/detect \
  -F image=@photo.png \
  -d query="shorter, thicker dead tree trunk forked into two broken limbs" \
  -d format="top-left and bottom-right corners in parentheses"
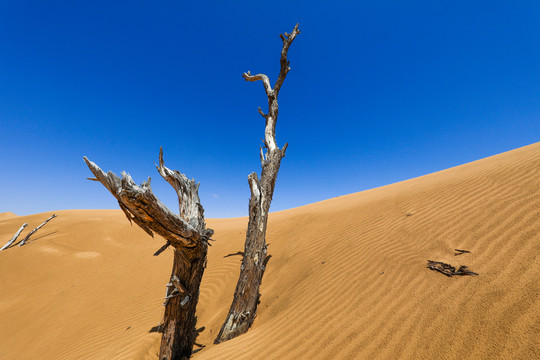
top-left (84, 149), bottom-right (214, 360)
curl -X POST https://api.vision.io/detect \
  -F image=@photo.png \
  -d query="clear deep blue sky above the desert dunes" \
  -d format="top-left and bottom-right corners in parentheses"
top-left (0, 0), bottom-right (540, 217)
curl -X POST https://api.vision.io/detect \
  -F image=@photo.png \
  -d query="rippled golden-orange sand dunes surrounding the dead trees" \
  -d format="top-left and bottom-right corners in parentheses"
top-left (0, 143), bottom-right (540, 360)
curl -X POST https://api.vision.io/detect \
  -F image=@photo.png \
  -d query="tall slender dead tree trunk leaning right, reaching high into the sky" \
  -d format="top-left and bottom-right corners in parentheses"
top-left (214, 24), bottom-right (300, 344)
